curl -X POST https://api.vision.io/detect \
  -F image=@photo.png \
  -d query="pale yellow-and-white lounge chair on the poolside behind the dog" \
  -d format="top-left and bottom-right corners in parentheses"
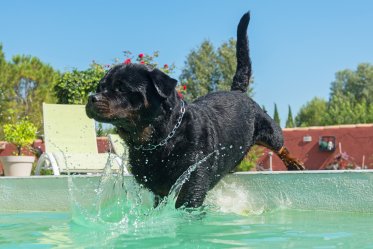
top-left (35, 103), bottom-right (129, 175)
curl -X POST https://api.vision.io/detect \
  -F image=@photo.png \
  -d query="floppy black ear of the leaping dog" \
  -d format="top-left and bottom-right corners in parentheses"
top-left (150, 69), bottom-right (177, 98)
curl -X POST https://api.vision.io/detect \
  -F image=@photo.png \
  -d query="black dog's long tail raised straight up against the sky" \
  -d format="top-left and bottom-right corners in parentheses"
top-left (231, 12), bottom-right (251, 92)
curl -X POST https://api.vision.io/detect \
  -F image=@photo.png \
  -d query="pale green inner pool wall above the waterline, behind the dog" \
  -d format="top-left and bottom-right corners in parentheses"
top-left (0, 170), bottom-right (373, 213)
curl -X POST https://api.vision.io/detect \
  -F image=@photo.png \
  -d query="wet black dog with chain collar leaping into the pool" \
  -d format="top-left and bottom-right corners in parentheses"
top-left (86, 13), bottom-right (304, 207)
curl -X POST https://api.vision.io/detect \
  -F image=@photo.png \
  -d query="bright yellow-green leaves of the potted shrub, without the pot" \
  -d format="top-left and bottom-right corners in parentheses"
top-left (3, 118), bottom-right (37, 156)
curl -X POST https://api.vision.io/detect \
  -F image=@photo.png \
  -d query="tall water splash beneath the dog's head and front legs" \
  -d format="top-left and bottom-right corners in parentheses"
top-left (68, 152), bottom-right (215, 234)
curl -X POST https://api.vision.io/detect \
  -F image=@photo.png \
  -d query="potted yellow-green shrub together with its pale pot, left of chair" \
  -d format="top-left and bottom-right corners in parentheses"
top-left (0, 118), bottom-right (37, 176)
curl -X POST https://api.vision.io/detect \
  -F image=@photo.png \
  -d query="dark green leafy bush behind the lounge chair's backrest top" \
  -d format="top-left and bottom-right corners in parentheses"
top-left (53, 63), bottom-right (105, 104)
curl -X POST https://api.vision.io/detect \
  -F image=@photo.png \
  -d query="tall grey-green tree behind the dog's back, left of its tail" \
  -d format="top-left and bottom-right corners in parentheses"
top-left (179, 39), bottom-right (251, 100)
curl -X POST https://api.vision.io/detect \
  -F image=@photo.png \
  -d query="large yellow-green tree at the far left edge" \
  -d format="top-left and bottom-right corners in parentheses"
top-left (0, 44), bottom-right (59, 136)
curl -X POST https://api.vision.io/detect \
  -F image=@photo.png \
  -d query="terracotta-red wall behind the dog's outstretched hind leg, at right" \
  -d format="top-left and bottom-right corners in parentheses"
top-left (260, 124), bottom-right (373, 170)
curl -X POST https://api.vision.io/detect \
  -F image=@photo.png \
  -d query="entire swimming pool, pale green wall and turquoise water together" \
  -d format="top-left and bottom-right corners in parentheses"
top-left (0, 171), bottom-right (373, 248)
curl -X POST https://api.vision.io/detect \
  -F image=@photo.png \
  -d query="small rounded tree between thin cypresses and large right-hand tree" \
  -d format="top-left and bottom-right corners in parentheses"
top-left (295, 97), bottom-right (328, 127)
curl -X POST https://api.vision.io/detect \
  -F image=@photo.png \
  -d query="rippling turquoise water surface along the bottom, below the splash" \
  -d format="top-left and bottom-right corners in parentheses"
top-left (0, 209), bottom-right (373, 248)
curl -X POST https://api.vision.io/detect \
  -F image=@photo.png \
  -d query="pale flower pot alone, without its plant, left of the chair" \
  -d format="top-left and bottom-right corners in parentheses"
top-left (0, 156), bottom-right (35, 176)
